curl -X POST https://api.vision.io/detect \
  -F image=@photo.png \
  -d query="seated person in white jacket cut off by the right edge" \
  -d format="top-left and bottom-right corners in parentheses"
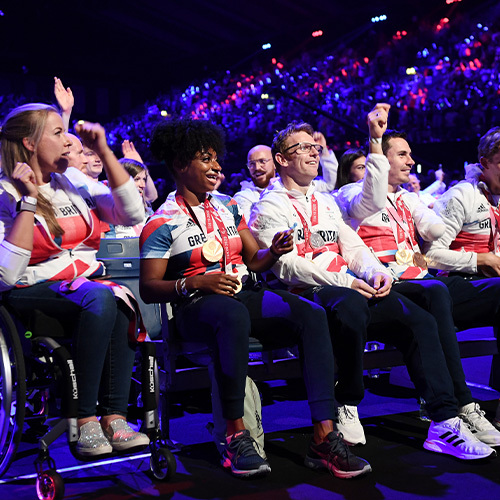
top-left (427, 127), bottom-right (500, 429)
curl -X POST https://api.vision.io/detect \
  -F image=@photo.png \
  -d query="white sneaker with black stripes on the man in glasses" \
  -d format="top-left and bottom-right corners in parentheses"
top-left (424, 417), bottom-right (496, 460)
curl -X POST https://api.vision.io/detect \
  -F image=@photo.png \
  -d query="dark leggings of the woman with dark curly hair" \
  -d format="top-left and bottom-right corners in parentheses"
top-left (175, 288), bottom-right (335, 422)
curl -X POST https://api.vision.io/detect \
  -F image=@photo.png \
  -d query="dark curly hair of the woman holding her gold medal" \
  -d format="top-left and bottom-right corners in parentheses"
top-left (150, 118), bottom-right (226, 178)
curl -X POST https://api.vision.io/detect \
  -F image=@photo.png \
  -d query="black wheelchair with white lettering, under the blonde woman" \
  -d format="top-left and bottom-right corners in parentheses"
top-left (0, 290), bottom-right (177, 500)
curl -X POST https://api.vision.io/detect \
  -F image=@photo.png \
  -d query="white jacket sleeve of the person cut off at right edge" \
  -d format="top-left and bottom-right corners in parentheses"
top-left (426, 184), bottom-right (477, 274)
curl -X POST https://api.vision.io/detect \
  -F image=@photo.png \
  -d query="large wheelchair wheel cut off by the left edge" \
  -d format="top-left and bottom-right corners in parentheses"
top-left (0, 307), bottom-right (26, 476)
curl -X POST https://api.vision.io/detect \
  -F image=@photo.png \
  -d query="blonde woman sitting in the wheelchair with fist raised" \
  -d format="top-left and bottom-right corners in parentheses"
top-left (0, 104), bottom-right (149, 457)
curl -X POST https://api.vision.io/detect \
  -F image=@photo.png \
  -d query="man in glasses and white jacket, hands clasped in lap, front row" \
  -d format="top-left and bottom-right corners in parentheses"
top-left (249, 122), bottom-right (495, 468)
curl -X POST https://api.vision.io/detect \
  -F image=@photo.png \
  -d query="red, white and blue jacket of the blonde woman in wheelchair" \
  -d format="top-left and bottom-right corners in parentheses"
top-left (0, 168), bottom-right (144, 291)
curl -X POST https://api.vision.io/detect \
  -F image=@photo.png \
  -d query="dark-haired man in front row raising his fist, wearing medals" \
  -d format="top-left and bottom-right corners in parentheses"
top-left (337, 103), bottom-right (500, 446)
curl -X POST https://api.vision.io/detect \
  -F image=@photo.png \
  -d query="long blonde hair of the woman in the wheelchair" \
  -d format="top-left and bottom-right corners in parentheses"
top-left (0, 103), bottom-right (64, 237)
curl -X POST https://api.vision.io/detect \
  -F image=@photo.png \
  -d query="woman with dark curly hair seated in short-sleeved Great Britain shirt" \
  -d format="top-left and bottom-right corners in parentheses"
top-left (140, 119), bottom-right (371, 478)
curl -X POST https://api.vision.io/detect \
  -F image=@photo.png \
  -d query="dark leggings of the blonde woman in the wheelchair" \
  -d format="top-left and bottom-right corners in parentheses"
top-left (4, 281), bottom-right (135, 418)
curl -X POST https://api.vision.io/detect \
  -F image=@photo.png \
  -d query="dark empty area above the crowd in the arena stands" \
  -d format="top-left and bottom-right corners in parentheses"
top-left (0, 0), bottom-right (492, 122)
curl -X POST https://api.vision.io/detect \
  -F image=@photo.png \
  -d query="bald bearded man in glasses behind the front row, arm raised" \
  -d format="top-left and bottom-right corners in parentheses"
top-left (234, 138), bottom-right (338, 221)
